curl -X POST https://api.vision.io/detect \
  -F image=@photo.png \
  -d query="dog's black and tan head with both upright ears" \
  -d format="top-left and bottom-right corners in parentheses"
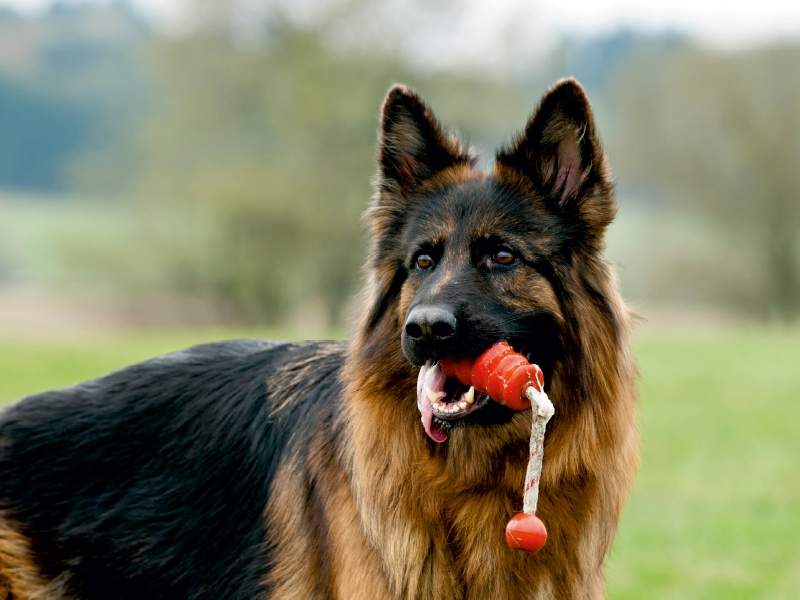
top-left (354, 79), bottom-right (616, 434)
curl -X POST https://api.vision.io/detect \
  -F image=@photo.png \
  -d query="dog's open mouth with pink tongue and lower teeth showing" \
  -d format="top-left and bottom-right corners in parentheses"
top-left (417, 361), bottom-right (489, 443)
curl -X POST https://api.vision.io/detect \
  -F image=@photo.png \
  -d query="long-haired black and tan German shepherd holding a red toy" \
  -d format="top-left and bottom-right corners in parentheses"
top-left (0, 80), bottom-right (638, 600)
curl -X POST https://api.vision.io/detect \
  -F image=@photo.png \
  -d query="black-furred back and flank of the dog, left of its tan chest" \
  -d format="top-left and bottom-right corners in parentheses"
top-left (0, 341), bottom-right (344, 600)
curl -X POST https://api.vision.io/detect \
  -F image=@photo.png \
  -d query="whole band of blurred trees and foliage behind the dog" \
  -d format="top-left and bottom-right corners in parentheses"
top-left (0, 0), bottom-right (800, 328)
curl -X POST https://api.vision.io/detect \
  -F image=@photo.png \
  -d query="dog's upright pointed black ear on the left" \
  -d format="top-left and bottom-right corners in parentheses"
top-left (378, 85), bottom-right (472, 196)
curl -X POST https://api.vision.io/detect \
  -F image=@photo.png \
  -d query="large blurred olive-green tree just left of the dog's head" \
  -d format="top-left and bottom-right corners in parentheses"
top-left (134, 3), bottom-right (530, 323)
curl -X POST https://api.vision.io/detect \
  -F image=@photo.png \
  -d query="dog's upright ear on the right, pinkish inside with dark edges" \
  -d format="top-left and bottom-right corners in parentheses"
top-left (496, 78), bottom-right (616, 230)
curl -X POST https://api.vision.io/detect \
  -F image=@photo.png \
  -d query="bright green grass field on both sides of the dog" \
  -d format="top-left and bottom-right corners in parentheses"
top-left (0, 329), bottom-right (800, 600)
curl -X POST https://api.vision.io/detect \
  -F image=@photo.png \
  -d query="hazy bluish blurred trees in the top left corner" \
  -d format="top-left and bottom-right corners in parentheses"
top-left (0, 0), bottom-right (149, 193)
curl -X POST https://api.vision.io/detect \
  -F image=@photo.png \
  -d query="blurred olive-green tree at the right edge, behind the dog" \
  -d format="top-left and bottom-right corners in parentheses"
top-left (606, 46), bottom-right (800, 318)
